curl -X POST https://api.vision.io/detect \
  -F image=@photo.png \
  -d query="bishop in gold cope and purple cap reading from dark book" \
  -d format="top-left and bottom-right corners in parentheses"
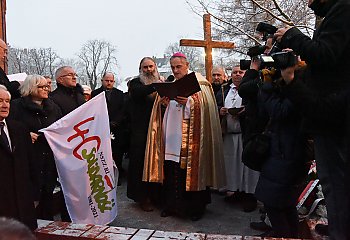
top-left (143, 53), bottom-right (225, 221)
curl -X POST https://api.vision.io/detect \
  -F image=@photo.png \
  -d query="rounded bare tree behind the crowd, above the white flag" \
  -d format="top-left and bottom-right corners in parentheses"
top-left (78, 40), bottom-right (117, 89)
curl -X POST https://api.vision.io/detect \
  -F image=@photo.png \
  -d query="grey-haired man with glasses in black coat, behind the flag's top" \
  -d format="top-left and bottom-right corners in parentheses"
top-left (50, 66), bottom-right (85, 115)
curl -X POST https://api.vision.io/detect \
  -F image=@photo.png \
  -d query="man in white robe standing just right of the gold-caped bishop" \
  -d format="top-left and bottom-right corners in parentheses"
top-left (216, 66), bottom-right (259, 212)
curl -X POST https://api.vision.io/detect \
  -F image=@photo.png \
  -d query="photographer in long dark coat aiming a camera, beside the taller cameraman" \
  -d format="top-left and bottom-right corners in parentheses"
top-left (245, 56), bottom-right (307, 238)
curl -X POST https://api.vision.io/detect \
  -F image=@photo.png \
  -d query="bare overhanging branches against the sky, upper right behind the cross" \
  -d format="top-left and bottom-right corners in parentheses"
top-left (187, 0), bottom-right (315, 58)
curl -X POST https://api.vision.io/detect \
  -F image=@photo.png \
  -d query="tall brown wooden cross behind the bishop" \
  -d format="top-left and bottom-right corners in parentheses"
top-left (180, 14), bottom-right (235, 83)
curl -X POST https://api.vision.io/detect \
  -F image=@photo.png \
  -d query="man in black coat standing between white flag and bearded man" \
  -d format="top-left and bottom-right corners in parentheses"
top-left (91, 72), bottom-right (124, 180)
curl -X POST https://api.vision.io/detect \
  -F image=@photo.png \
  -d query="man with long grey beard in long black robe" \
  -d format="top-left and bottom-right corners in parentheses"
top-left (127, 57), bottom-right (163, 212)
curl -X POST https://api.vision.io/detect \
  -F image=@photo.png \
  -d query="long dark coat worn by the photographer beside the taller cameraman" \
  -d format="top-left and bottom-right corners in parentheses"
top-left (255, 83), bottom-right (308, 208)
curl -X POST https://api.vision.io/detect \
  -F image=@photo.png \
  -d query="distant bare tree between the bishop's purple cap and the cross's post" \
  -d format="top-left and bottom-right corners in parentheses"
top-left (165, 41), bottom-right (205, 75)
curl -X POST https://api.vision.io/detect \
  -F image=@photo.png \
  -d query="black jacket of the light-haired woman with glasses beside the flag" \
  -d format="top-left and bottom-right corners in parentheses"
top-left (9, 96), bottom-right (62, 192)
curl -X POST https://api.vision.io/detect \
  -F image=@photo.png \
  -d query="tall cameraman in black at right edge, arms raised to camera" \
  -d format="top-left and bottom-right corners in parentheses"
top-left (275, 0), bottom-right (350, 240)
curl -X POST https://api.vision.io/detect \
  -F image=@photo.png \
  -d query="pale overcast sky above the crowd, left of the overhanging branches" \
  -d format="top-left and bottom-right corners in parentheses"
top-left (6, 0), bottom-right (203, 79)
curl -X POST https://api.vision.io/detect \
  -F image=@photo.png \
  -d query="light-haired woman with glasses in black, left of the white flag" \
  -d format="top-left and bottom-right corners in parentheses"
top-left (10, 75), bottom-right (62, 220)
